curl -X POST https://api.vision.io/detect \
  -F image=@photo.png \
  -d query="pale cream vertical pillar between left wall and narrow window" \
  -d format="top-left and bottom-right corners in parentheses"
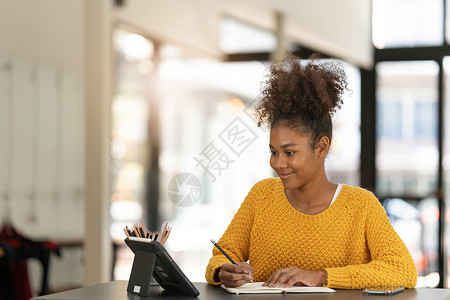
top-left (84, 0), bottom-right (112, 285)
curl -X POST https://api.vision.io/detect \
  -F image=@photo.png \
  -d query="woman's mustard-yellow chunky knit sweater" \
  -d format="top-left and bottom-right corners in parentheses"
top-left (205, 178), bottom-right (417, 289)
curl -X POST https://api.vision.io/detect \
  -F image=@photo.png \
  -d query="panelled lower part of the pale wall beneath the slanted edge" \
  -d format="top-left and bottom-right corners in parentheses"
top-left (0, 52), bottom-right (84, 239)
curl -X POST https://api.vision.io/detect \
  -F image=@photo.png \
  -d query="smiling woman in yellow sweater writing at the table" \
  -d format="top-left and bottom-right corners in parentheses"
top-left (206, 55), bottom-right (417, 289)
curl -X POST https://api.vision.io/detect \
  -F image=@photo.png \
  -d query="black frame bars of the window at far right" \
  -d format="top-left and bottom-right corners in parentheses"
top-left (368, 0), bottom-right (450, 288)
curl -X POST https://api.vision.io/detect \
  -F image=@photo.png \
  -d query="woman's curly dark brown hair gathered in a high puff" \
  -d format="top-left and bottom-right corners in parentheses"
top-left (256, 53), bottom-right (347, 149)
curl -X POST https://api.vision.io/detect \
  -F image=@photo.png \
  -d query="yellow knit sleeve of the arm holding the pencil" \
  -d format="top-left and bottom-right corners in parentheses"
top-left (205, 182), bottom-right (262, 285)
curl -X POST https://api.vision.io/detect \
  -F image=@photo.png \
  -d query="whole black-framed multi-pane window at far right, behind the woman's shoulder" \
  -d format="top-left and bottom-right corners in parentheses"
top-left (372, 0), bottom-right (450, 287)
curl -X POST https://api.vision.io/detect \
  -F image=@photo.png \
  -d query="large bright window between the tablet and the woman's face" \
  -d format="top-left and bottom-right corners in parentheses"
top-left (159, 46), bottom-right (272, 281)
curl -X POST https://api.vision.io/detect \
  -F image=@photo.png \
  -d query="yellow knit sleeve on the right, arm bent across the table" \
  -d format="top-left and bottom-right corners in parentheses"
top-left (325, 193), bottom-right (417, 289)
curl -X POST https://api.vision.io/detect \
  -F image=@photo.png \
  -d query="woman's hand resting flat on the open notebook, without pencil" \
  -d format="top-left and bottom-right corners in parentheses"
top-left (263, 267), bottom-right (328, 287)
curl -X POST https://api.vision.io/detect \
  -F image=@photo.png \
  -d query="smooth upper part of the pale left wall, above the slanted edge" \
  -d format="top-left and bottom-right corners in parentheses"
top-left (0, 0), bottom-right (84, 72)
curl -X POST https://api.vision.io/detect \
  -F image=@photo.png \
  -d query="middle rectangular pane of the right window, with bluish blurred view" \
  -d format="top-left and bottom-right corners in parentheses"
top-left (376, 61), bottom-right (439, 196)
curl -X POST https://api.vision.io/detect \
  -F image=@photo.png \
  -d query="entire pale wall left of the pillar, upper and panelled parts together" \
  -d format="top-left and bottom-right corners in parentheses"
top-left (0, 0), bottom-right (85, 290)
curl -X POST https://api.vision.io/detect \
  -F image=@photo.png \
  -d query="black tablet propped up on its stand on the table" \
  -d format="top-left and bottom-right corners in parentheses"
top-left (125, 237), bottom-right (199, 297)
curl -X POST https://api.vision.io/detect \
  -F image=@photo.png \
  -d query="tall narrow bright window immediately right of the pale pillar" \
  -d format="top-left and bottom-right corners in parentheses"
top-left (110, 28), bottom-right (155, 279)
